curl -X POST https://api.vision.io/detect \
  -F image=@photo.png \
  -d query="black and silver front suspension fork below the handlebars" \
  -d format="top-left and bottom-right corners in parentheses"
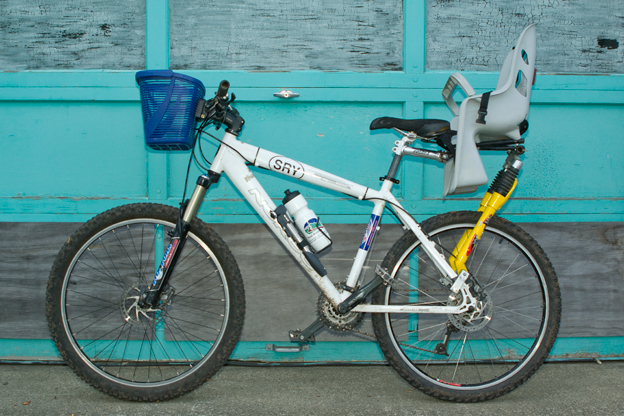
top-left (141, 172), bottom-right (221, 308)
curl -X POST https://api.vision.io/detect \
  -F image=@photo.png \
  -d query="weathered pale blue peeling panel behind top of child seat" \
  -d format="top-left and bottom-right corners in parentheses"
top-left (426, 0), bottom-right (624, 74)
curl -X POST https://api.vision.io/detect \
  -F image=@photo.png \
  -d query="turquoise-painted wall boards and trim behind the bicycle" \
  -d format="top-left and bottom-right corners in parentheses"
top-left (0, 0), bottom-right (624, 360)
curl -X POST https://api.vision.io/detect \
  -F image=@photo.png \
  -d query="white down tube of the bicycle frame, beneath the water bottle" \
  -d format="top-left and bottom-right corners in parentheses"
top-left (222, 149), bottom-right (348, 305)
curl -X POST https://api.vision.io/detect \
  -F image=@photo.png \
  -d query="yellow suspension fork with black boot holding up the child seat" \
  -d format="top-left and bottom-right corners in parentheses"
top-left (449, 151), bottom-right (522, 273)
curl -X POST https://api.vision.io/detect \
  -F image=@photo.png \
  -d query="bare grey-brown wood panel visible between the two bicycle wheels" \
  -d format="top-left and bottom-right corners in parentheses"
top-left (214, 223), bottom-right (402, 341)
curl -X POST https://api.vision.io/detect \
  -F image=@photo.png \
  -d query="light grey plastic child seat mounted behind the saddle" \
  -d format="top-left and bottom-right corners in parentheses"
top-left (442, 25), bottom-right (536, 196)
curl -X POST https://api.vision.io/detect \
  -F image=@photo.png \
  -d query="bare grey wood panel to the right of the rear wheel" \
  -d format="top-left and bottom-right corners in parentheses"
top-left (522, 222), bottom-right (624, 337)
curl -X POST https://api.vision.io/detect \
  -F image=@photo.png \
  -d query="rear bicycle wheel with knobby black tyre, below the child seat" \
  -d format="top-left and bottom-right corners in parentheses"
top-left (373, 212), bottom-right (561, 402)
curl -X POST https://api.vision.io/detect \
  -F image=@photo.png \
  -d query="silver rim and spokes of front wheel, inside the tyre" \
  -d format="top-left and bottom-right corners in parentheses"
top-left (61, 218), bottom-right (230, 388)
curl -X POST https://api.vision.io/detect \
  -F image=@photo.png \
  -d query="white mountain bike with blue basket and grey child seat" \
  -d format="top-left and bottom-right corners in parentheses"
top-left (46, 26), bottom-right (561, 402)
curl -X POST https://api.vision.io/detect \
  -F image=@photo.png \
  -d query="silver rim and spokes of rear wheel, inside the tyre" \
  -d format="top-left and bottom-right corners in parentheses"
top-left (385, 223), bottom-right (550, 390)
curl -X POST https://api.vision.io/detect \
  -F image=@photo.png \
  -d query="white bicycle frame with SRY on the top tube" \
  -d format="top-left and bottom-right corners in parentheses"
top-left (193, 132), bottom-right (476, 314)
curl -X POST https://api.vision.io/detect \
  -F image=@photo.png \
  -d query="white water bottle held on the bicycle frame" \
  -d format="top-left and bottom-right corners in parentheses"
top-left (282, 190), bottom-right (331, 253)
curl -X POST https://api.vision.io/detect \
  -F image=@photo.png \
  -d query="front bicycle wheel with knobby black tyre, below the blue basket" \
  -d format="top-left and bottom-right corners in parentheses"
top-left (46, 204), bottom-right (245, 401)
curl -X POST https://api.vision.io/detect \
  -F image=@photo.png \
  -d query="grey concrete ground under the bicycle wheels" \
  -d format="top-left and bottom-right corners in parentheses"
top-left (0, 361), bottom-right (624, 416)
